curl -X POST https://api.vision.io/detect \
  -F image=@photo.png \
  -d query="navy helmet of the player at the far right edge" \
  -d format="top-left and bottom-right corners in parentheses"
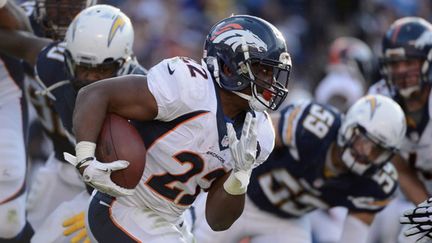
top-left (380, 17), bottom-right (432, 101)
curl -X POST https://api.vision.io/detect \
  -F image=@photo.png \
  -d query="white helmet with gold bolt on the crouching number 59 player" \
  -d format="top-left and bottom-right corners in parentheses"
top-left (338, 95), bottom-right (406, 175)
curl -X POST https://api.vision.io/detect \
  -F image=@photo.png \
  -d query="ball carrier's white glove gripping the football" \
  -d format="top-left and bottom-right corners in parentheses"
top-left (63, 153), bottom-right (135, 197)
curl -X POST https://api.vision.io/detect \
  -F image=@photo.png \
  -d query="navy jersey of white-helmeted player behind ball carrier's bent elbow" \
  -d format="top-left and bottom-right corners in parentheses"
top-left (27, 42), bottom-right (147, 160)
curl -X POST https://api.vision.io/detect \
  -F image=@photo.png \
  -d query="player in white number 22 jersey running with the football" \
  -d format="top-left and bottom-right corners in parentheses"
top-left (66, 15), bottom-right (291, 242)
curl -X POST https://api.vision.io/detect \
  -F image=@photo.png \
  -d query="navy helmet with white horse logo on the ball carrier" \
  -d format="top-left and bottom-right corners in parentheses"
top-left (204, 15), bottom-right (291, 110)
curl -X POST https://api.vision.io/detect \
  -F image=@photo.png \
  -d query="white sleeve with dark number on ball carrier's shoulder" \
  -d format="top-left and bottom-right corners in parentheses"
top-left (147, 57), bottom-right (215, 121)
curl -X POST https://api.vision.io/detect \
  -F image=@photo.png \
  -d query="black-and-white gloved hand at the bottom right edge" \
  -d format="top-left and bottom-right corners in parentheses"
top-left (399, 198), bottom-right (432, 243)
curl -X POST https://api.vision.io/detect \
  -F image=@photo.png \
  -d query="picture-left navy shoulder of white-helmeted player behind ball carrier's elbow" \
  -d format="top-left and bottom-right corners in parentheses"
top-left (34, 42), bottom-right (68, 86)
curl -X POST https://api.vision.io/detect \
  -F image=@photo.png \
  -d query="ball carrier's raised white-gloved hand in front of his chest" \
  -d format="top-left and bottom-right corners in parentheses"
top-left (224, 112), bottom-right (258, 195)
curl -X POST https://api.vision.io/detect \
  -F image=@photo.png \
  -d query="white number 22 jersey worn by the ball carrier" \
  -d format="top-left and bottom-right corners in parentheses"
top-left (118, 57), bottom-right (275, 222)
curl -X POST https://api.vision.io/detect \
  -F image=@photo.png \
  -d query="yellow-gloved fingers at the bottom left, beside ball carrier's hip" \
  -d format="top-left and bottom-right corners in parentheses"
top-left (63, 212), bottom-right (90, 243)
